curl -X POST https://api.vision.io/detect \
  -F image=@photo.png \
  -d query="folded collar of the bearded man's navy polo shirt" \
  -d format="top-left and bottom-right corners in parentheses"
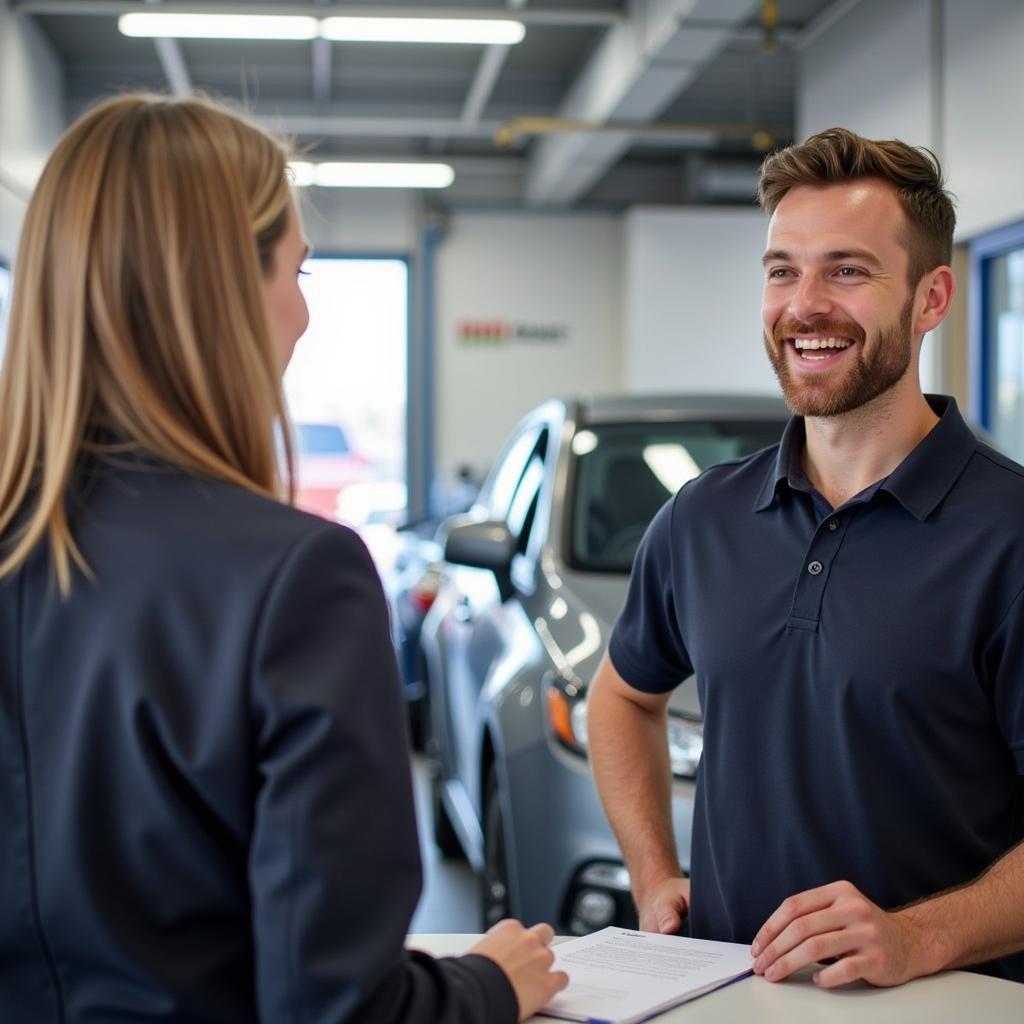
top-left (754, 394), bottom-right (977, 520)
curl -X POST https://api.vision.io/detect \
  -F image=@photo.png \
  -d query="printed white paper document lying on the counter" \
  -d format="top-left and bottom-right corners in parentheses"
top-left (541, 928), bottom-right (754, 1024)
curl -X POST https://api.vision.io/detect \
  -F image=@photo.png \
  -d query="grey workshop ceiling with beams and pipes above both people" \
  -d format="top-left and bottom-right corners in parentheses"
top-left (16, 0), bottom-right (856, 210)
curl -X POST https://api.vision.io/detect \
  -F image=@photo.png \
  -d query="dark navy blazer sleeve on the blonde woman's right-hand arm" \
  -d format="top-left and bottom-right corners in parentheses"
top-left (249, 522), bottom-right (518, 1024)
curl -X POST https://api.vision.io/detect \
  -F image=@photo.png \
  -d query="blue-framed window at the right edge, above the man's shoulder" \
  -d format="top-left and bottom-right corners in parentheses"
top-left (970, 221), bottom-right (1024, 461)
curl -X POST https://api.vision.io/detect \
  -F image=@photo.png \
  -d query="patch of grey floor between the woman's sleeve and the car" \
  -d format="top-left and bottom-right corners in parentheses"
top-left (410, 755), bottom-right (480, 933)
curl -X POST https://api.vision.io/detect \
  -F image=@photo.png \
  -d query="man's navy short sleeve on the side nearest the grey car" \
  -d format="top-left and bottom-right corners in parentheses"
top-left (608, 496), bottom-right (693, 693)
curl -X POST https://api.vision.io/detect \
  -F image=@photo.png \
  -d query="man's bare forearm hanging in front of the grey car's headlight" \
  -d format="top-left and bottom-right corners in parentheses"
top-left (588, 671), bottom-right (680, 900)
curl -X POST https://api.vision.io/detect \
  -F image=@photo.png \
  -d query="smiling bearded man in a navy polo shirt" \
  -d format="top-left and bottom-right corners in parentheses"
top-left (589, 129), bottom-right (1024, 987)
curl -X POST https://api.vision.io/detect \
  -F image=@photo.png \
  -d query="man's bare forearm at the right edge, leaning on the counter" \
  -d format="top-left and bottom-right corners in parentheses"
top-left (897, 843), bottom-right (1024, 974)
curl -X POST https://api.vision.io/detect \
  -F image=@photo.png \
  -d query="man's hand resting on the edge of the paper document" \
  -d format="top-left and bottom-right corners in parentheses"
top-left (751, 882), bottom-right (929, 988)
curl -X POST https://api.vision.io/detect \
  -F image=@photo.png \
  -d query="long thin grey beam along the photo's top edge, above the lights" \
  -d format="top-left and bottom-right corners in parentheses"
top-left (10, 0), bottom-right (624, 28)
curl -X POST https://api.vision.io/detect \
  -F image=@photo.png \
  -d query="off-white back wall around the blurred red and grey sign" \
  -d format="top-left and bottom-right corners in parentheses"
top-left (434, 212), bottom-right (625, 474)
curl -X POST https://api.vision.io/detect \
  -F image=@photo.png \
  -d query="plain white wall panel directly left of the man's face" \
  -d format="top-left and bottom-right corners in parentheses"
top-left (626, 207), bottom-right (777, 393)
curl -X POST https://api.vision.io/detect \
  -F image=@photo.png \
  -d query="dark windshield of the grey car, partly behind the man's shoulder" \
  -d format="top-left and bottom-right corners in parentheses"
top-left (570, 420), bottom-right (785, 572)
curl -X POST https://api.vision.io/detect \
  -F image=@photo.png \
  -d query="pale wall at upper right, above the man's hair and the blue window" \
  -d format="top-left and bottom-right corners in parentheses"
top-left (797, 0), bottom-right (1024, 390)
